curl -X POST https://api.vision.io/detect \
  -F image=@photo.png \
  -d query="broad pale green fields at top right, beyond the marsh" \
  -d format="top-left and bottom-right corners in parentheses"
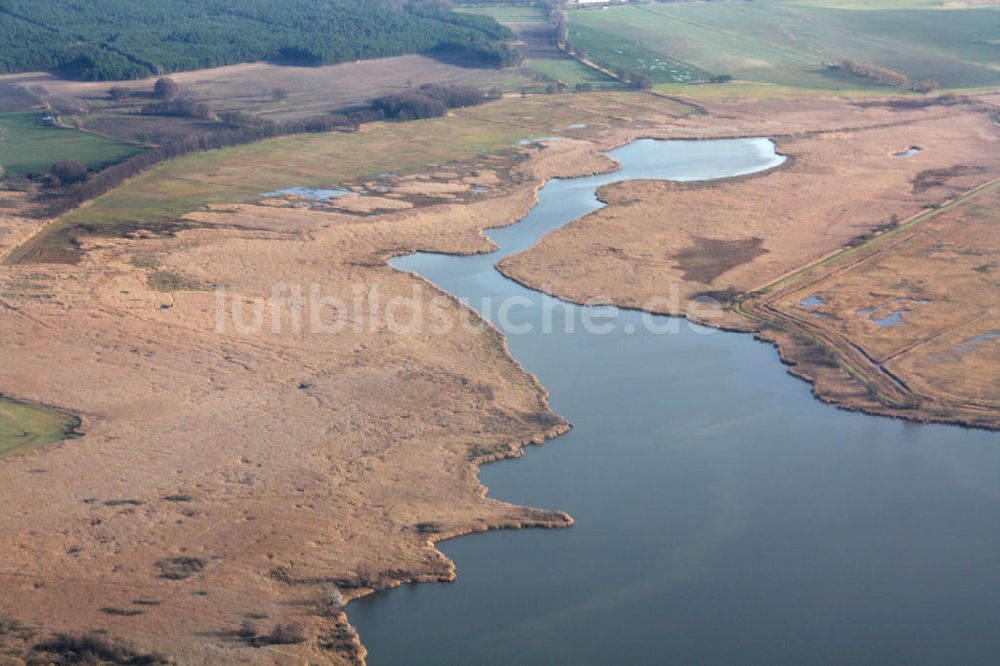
top-left (567, 0), bottom-right (1000, 90)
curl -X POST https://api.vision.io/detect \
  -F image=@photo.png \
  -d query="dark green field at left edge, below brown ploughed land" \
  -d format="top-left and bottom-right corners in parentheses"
top-left (0, 111), bottom-right (143, 175)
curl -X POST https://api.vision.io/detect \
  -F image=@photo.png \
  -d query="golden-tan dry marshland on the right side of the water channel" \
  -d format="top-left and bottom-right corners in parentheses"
top-left (500, 94), bottom-right (1000, 427)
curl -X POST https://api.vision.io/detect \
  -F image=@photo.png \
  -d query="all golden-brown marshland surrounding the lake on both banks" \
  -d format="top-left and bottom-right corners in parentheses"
top-left (0, 93), bottom-right (1000, 664)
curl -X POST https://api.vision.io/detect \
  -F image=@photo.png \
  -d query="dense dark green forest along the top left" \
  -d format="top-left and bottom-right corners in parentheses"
top-left (0, 0), bottom-right (517, 81)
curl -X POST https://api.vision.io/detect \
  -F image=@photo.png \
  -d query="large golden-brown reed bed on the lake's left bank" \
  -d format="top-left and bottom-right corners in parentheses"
top-left (0, 101), bottom-right (656, 664)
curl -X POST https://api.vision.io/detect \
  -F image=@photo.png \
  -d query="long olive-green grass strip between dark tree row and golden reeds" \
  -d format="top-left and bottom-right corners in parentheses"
top-left (58, 116), bottom-right (528, 226)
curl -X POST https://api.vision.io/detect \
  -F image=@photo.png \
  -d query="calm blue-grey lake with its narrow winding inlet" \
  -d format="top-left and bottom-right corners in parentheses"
top-left (348, 139), bottom-right (1000, 666)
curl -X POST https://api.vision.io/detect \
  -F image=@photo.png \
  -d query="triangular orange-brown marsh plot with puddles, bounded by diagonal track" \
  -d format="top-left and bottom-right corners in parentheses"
top-left (761, 179), bottom-right (1000, 427)
